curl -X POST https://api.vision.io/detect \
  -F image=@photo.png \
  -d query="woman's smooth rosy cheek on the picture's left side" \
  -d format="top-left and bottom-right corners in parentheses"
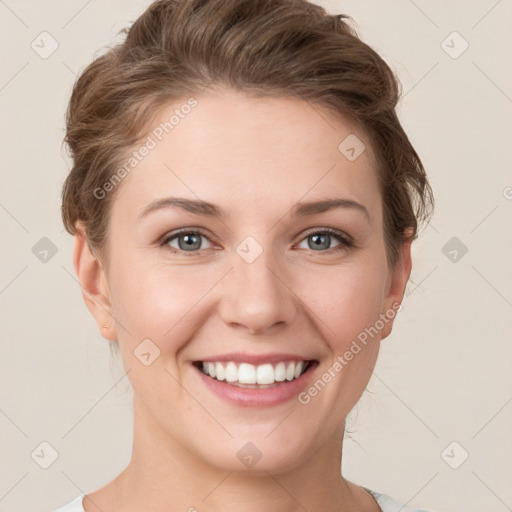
top-left (107, 258), bottom-right (218, 398)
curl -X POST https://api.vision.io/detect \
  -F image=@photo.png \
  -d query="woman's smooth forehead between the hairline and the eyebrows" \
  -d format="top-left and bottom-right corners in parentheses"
top-left (113, 89), bottom-right (380, 220)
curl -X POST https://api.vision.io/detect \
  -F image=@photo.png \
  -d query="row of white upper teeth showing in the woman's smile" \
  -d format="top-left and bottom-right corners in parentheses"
top-left (202, 361), bottom-right (305, 385)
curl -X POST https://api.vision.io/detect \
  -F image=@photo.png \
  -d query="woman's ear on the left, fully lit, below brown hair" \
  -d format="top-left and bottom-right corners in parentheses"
top-left (73, 225), bottom-right (117, 341)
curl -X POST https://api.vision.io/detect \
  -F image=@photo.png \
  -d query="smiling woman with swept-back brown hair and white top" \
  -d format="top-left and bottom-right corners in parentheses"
top-left (60, 0), bottom-right (433, 512)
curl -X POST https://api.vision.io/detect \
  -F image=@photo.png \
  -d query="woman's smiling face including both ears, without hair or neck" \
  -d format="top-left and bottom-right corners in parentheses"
top-left (75, 89), bottom-right (410, 472)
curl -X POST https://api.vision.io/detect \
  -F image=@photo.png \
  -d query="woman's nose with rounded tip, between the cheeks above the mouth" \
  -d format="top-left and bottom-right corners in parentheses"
top-left (220, 245), bottom-right (300, 334)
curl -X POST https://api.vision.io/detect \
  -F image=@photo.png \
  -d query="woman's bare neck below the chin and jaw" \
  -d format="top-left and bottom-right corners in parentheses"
top-left (111, 399), bottom-right (372, 512)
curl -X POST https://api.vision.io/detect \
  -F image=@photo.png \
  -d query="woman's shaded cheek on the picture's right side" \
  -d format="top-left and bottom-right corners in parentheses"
top-left (296, 261), bottom-right (387, 408)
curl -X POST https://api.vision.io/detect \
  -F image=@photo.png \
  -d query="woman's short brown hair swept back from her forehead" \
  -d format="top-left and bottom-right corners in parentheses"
top-left (62, 0), bottom-right (434, 267)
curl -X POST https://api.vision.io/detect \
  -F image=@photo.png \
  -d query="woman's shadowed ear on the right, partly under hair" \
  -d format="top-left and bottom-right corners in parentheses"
top-left (381, 230), bottom-right (412, 340)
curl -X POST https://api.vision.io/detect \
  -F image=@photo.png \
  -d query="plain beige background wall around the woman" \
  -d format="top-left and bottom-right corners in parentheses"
top-left (0, 0), bottom-right (512, 512)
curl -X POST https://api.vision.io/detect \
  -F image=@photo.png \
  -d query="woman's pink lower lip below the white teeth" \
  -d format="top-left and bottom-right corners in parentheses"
top-left (194, 362), bottom-right (317, 407)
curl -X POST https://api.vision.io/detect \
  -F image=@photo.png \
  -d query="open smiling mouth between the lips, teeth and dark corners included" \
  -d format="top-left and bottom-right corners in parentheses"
top-left (194, 360), bottom-right (316, 389)
